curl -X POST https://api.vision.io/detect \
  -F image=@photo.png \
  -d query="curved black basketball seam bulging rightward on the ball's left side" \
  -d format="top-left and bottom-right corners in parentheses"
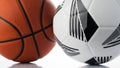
top-left (0, 17), bottom-right (24, 61)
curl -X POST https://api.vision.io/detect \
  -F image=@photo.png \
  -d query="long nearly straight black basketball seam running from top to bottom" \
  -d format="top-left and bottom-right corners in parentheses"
top-left (18, 0), bottom-right (40, 58)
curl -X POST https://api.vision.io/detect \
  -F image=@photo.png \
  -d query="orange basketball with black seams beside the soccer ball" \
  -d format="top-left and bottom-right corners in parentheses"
top-left (0, 0), bottom-right (55, 62)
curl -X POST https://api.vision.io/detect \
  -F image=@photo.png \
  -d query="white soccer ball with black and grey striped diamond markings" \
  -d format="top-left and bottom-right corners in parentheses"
top-left (54, 0), bottom-right (120, 65)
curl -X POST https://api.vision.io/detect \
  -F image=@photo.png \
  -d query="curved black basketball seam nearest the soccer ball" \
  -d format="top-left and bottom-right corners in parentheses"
top-left (40, 0), bottom-right (55, 42)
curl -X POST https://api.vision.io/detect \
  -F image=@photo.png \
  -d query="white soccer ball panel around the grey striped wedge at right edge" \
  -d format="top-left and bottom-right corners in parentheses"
top-left (88, 27), bottom-right (120, 58)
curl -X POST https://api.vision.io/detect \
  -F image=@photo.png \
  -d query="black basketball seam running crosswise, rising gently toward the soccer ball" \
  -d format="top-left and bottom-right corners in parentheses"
top-left (0, 24), bottom-right (52, 43)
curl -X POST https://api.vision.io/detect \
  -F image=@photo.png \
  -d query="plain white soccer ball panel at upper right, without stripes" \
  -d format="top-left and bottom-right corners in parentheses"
top-left (88, 0), bottom-right (120, 27)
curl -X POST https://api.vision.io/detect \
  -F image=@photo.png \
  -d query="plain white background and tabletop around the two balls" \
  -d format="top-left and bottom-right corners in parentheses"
top-left (0, 0), bottom-right (120, 68)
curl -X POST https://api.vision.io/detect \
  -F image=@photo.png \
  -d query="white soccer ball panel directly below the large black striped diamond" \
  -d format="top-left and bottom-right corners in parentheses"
top-left (63, 36), bottom-right (93, 62)
